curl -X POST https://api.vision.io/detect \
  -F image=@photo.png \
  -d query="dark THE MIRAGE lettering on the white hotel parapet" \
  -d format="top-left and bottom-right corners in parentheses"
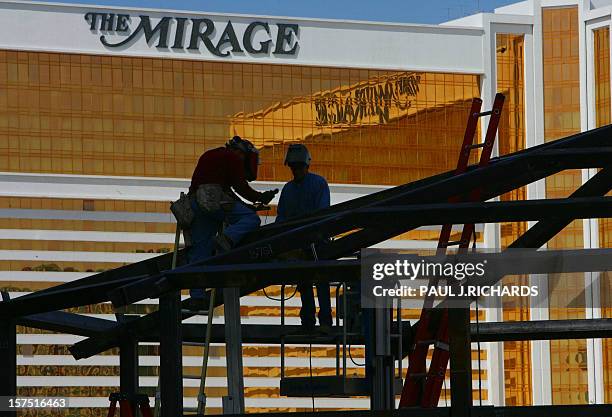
top-left (84, 12), bottom-right (299, 57)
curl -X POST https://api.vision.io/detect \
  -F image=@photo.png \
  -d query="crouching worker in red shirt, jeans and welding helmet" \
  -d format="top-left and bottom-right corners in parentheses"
top-left (188, 136), bottom-right (278, 262)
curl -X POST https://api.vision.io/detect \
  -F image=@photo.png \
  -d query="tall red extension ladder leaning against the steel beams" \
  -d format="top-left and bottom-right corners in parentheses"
top-left (399, 93), bottom-right (505, 408)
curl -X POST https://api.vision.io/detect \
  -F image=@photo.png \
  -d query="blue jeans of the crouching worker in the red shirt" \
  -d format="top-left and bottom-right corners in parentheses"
top-left (187, 199), bottom-right (261, 297)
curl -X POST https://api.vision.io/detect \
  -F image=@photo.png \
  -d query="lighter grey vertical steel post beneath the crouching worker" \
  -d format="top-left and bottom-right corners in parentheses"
top-left (224, 288), bottom-right (244, 417)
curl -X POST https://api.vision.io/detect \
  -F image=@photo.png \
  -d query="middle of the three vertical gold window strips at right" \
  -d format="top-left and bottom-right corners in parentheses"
top-left (542, 7), bottom-right (588, 404)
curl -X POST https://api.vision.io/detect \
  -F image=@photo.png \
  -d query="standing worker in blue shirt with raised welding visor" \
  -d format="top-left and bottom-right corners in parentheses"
top-left (276, 144), bottom-right (332, 332)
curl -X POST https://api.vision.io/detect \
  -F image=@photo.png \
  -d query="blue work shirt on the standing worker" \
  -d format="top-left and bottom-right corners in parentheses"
top-left (276, 172), bottom-right (329, 222)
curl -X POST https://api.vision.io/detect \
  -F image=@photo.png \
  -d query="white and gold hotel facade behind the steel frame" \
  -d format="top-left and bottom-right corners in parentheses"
top-left (0, 0), bottom-right (612, 415)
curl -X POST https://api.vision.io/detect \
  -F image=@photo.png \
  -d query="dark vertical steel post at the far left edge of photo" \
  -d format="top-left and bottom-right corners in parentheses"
top-left (0, 291), bottom-right (17, 417)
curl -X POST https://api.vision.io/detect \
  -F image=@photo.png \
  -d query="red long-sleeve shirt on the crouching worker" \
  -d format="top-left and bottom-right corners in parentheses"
top-left (189, 148), bottom-right (260, 202)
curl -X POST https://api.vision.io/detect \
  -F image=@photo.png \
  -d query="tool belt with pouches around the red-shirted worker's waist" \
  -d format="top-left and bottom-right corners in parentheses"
top-left (170, 184), bottom-right (236, 230)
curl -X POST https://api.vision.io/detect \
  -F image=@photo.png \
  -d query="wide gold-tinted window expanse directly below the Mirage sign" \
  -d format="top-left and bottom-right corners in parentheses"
top-left (0, 51), bottom-right (480, 184)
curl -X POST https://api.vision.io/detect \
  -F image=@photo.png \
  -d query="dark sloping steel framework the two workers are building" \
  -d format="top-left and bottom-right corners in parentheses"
top-left (0, 122), bottom-right (612, 417)
